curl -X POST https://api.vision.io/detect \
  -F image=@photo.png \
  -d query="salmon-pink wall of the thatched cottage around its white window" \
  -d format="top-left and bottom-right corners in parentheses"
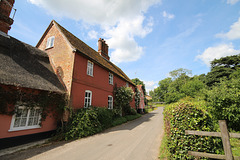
top-left (0, 85), bottom-right (57, 139)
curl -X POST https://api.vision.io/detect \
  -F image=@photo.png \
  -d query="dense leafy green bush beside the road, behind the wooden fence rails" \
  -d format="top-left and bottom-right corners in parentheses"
top-left (164, 101), bottom-right (223, 159)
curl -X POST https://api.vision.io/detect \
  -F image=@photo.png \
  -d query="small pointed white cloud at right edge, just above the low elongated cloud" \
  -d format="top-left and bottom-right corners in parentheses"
top-left (216, 18), bottom-right (240, 40)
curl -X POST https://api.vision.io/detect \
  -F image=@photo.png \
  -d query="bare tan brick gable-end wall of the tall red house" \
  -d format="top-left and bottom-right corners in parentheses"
top-left (37, 23), bottom-right (74, 96)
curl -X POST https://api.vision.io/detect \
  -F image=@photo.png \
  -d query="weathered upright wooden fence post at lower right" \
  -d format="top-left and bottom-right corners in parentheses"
top-left (219, 120), bottom-right (233, 160)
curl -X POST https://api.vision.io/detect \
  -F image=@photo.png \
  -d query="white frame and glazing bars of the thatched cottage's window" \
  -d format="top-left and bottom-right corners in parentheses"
top-left (9, 106), bottom-right (42, 132)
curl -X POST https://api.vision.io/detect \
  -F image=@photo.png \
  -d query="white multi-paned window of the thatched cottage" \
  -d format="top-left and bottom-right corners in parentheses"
top-left (10, 106), bottom-right (42, 131)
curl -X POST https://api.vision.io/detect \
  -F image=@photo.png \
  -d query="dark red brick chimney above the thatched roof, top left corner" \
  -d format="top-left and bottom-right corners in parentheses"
top-left (0, 0), bottom-right (15, 34)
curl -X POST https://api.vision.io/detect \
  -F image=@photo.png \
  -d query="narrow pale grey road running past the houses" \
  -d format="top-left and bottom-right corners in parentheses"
top-left (0, 107), bottom-right (164, 160)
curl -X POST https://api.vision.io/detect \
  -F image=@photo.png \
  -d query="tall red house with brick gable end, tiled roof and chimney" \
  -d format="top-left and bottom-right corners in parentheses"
top-left (36, 20), bottom-right (135, 109)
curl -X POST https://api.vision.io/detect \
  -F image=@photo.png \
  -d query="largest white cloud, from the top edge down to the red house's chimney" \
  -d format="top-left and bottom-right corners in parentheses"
top-left (28, 0), bottom-right (161, 63)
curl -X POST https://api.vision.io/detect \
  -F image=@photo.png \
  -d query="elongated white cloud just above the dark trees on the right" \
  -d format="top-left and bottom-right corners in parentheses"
top-left (196, 44), bottom-right (240, 67)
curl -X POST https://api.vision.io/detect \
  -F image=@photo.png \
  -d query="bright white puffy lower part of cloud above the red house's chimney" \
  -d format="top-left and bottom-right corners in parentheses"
top-left (104, 16), bottom-right (152, 63)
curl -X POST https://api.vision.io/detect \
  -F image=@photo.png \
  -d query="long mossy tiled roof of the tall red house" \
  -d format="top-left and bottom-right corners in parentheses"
top-left (37, 20), bottom-right (135, 86)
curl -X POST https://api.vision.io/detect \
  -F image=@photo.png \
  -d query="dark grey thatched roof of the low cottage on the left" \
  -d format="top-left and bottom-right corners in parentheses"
top-left (0, 35), bottom-right (64, 93)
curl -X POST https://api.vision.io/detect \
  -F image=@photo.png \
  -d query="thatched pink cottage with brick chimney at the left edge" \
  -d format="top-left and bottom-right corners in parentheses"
top-left (0, 0), bottom-right (65, 149)
